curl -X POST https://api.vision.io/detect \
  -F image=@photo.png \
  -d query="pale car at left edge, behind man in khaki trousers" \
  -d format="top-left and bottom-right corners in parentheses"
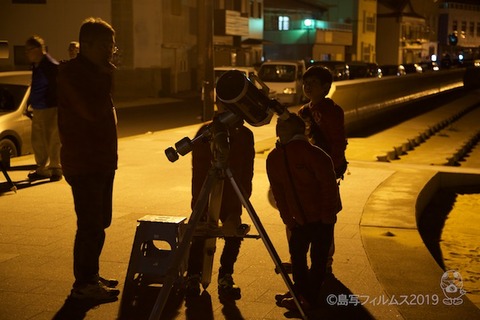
top-left (0, 71), bottom-right (32, 157)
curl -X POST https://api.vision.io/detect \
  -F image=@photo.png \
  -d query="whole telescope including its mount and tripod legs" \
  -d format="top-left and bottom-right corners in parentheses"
top-left (156, 70), bottom-right (307, 320)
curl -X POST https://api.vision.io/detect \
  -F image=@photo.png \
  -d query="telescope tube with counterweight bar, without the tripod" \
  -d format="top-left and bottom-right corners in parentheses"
top-left (165, 69), bottom-right (289, 162)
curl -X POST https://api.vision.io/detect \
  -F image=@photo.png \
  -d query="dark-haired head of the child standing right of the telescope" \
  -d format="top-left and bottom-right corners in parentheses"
top-left (303, 66), bottom-right (333, 102)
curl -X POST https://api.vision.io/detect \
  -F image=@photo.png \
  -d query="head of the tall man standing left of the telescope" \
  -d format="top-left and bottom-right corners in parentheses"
top-left (79, 18), bottom-right (117, 66)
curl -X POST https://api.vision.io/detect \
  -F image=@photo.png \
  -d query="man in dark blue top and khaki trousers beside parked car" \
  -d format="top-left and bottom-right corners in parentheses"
top-left (25, 35), bottom-right (62, 181)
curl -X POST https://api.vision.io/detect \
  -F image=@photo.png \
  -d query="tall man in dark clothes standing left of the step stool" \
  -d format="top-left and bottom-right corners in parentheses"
top-left (57, 18), bottom-right (120, 303)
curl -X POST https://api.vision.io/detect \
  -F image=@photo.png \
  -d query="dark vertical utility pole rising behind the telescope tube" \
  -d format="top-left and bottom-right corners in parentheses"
top-left (197, 0), bottom-right (215, 121)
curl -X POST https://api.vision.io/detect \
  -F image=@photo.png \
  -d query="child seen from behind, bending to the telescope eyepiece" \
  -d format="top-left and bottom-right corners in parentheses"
top-left (266, 114), bottom-right (340, 311)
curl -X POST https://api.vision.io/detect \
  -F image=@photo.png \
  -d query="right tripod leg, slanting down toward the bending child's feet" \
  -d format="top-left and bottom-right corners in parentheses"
top-left (226, 168), bottom-right (308, 320)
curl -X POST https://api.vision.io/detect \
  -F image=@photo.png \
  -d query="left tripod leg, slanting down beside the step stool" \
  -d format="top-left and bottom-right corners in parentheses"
top-left (148, 168), bottom-right (216, 320)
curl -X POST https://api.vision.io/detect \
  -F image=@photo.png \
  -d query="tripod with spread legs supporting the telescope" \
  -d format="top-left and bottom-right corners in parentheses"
top-left (149, 118), bottom-right (307, 320)
